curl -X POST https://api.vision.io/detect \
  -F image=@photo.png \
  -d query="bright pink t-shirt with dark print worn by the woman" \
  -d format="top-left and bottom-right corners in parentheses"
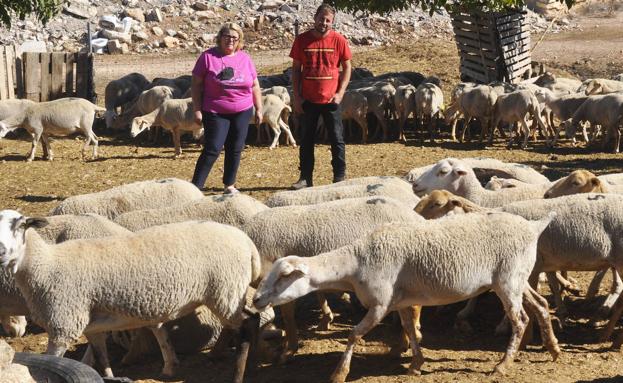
top-left (193, 48), bottom-right (257, 114)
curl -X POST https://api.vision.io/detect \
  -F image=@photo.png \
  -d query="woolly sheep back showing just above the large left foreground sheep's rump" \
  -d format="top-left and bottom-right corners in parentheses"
top-left (115, 194), bottom-right (268, 231)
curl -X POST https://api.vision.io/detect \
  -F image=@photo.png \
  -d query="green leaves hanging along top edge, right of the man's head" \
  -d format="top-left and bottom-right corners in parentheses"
top-left (329, 0), bottom-right (576, 14)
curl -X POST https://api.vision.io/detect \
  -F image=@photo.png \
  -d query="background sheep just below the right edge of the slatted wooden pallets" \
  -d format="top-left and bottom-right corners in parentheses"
top-left (489, 89), bottom-right (547, 149)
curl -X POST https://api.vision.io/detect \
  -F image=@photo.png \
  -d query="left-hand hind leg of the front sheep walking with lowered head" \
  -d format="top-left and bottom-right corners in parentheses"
top-left (495, 291), bottom-right (529, 374)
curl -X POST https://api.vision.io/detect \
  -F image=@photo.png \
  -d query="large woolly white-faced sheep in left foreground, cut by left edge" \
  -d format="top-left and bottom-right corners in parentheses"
top-left (0, 210), bottom-right (260, 376)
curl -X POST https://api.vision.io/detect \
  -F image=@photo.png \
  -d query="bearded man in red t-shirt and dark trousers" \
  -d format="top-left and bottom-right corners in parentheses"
top-left (290, 4), bottom-right (351, 189)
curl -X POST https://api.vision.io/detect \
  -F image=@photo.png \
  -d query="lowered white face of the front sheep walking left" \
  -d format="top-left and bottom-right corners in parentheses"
top-left (253, 256), bottom-right (313, 310)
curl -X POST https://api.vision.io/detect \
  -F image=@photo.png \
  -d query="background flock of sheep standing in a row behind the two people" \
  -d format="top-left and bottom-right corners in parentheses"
top-left (0, 68), bottom-right (623, 161)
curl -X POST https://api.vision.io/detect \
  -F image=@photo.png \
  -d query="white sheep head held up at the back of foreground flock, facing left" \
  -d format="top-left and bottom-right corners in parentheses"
top-left (413, 158), bottom-right (467, 197)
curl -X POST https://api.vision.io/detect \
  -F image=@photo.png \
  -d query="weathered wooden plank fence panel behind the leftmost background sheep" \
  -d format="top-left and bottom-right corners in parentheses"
top-left (18, 52), bottom-right (95, 102)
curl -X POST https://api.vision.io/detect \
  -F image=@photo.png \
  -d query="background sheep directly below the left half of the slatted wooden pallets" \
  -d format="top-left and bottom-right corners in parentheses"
top-left (446, 85), bottom-right (497, 142)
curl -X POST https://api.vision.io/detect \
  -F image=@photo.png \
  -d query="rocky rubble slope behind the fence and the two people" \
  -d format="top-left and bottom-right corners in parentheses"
top-left (0, 0), bottom-right (573, 54)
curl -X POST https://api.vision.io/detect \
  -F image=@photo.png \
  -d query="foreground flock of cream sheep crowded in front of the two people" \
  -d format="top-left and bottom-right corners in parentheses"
top-left (0, 158), bottom-right (623, 382)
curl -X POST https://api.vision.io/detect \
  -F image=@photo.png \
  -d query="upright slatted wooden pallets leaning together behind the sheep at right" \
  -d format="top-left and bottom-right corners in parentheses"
top-left (452, 12), bottom-right (531, 83)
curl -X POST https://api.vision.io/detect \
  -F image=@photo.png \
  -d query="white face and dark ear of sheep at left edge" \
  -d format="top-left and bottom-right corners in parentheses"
top-left (0, 210), bottom-right (47, 273)
